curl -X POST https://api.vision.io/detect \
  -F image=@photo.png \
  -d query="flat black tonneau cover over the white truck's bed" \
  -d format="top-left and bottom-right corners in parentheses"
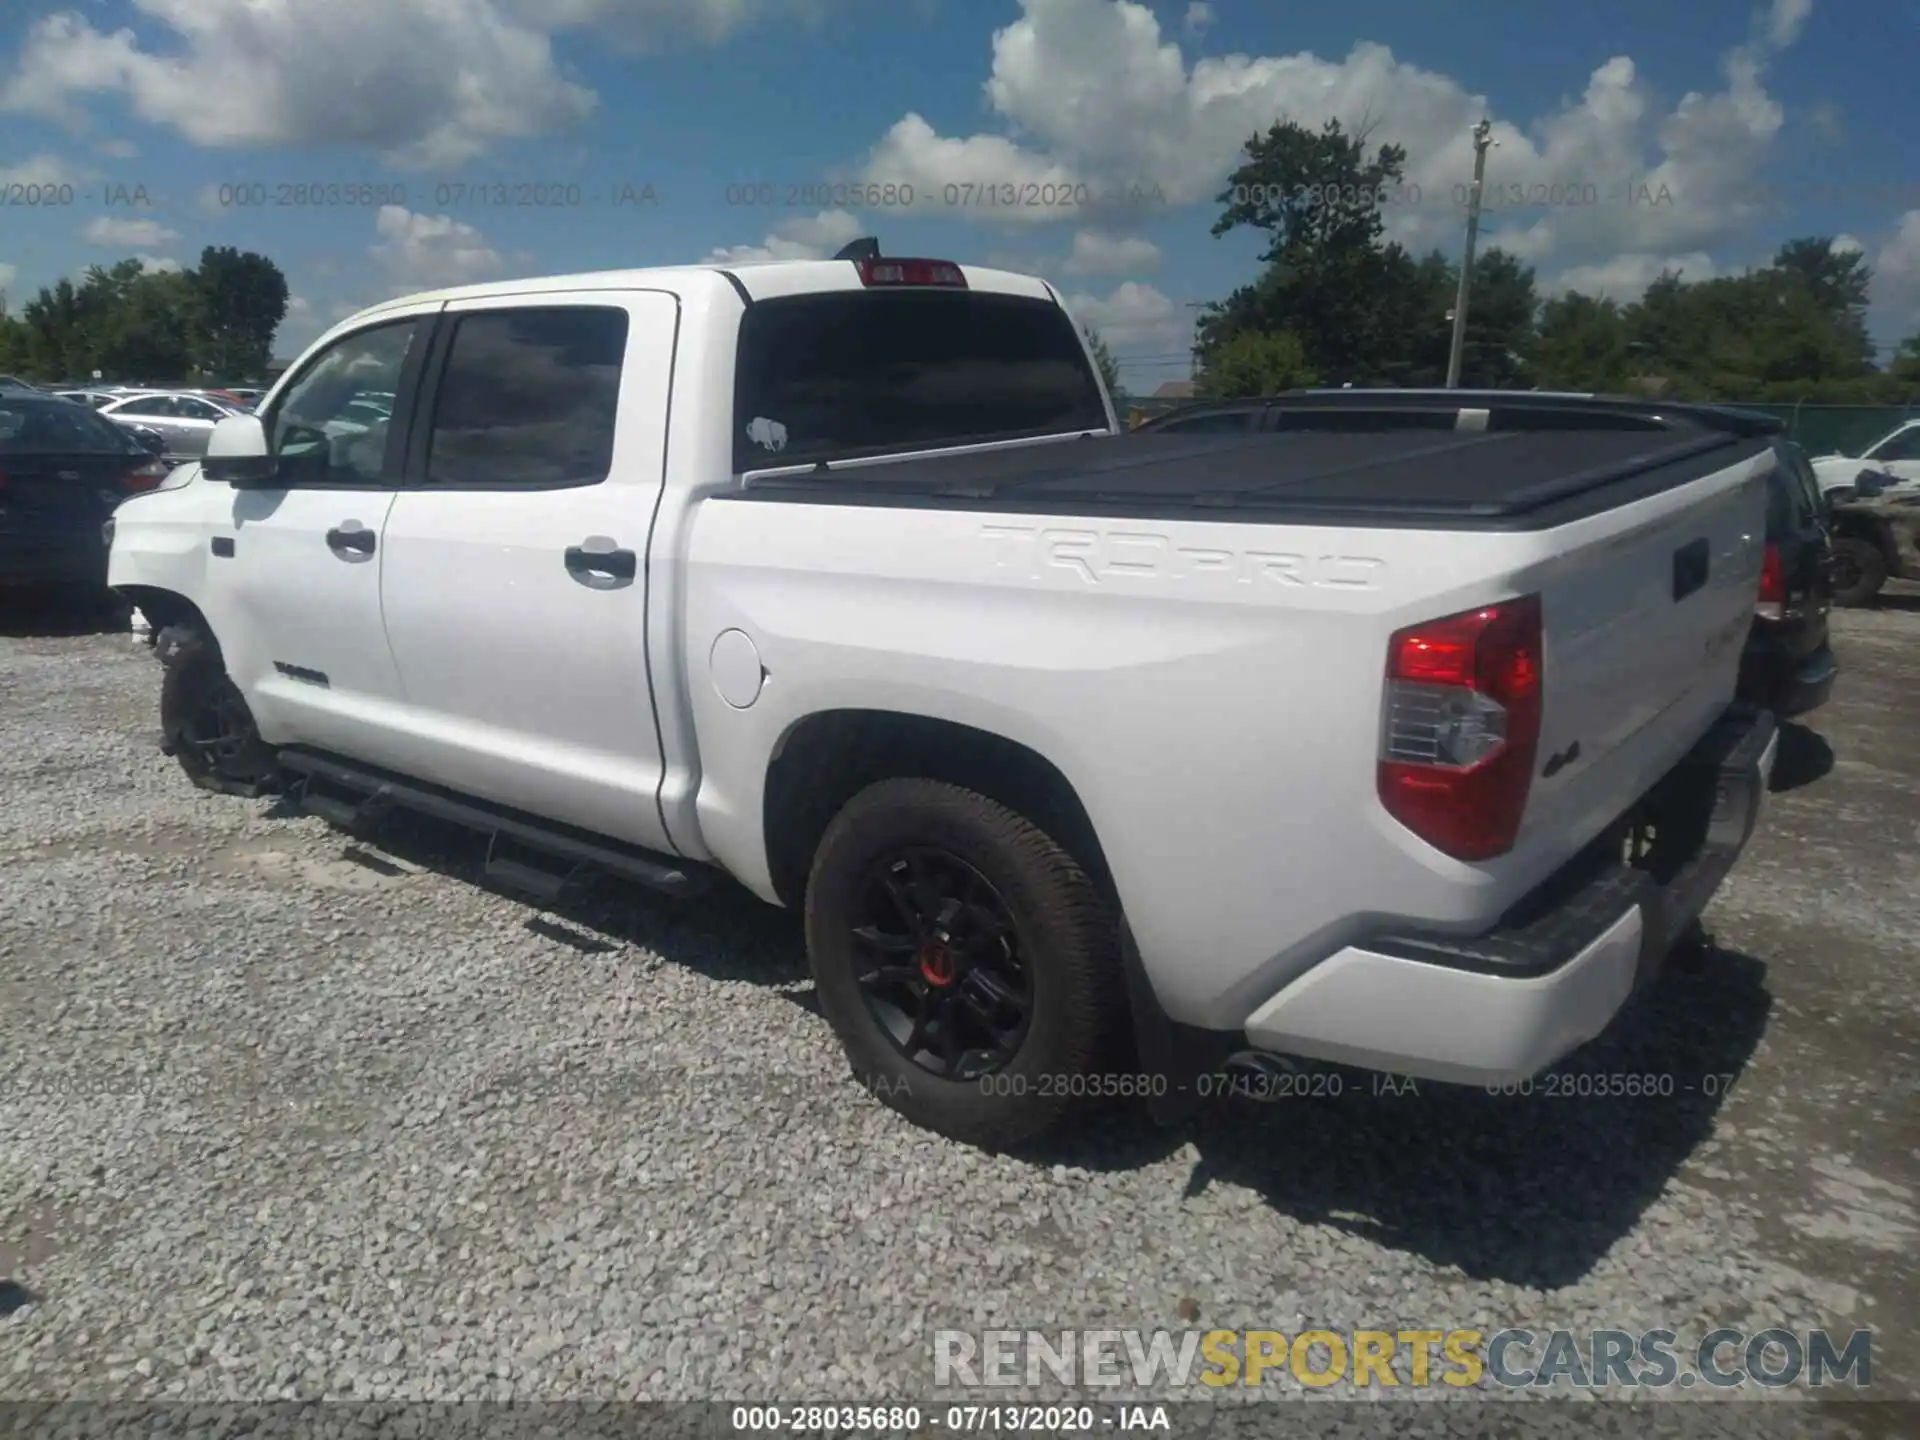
top-left (739, 390), bottom-right (1782, 528)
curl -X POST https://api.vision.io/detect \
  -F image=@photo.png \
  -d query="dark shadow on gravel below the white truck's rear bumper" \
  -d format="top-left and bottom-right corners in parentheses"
top-left (1054, 948), bottom-right (1772, 1290)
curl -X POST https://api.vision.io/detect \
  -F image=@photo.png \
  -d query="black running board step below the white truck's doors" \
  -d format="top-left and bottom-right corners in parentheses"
top-left (280, 749), bottom-right (712, 900)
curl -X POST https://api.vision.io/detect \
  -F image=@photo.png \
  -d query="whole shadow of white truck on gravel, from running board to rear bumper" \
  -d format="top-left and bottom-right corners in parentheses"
top-left (280, 803), bottom-right (1772, 1290)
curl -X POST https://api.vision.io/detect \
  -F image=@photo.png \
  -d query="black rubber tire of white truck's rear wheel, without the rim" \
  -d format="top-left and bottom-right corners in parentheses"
top-left (806, 780), bottom-right (1125, 1150)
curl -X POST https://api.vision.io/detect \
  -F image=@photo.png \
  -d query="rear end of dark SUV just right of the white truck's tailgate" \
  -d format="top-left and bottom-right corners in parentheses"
top-left (1740, 440), bottom-right (1837, 718)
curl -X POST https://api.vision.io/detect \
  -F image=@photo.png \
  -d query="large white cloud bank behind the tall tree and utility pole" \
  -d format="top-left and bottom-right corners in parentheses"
top-left (868, 0), bottom-right (1809, 267)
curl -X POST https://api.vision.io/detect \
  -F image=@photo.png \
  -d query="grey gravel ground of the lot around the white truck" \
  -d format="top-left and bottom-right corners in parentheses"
top-left (0, 595), bottom-right (1920, 1434)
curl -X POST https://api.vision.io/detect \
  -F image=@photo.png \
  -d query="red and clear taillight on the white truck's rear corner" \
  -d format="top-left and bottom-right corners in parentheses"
top-left (1379, 595), bottom-right (1544, 860)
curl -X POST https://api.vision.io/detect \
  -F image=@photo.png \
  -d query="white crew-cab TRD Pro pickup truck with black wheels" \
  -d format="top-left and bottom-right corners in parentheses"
top-left (109, 246), bottom-right (1776, 1146)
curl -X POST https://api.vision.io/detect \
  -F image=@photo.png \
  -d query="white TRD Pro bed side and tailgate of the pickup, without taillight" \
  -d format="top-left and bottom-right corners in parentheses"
top-left (685, 442), bottom-right (1770, 1027)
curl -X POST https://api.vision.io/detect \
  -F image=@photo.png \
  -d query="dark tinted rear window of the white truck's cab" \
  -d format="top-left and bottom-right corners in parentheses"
top-left (733, 290), bottom-right (1108, 470)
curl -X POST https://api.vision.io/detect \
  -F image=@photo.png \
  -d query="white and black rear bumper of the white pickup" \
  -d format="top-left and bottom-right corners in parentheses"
top-left (1246, 708), bottom-right (1780, 1085)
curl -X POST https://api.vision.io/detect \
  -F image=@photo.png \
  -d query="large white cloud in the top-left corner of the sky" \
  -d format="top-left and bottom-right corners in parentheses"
top-left (0, 0), bottom-right (831, 167)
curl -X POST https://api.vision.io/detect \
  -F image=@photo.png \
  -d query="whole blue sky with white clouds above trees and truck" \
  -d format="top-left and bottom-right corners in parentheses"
top-left (0, 0), bottom-right (1920, 390)
